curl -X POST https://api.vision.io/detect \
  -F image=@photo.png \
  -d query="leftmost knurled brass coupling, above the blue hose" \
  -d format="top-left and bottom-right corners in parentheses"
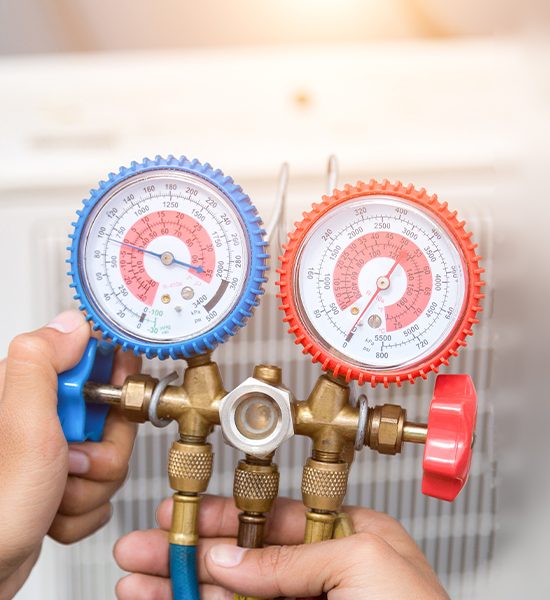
top-left (168, 442), bottom-right (214, 494)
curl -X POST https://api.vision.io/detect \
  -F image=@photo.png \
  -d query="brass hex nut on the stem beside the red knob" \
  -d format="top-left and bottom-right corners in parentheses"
top-left (366, 404), bottom-right (407, 454)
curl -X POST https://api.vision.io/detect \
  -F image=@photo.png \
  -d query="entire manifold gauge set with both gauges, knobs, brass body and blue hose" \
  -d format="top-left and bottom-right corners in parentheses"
top-left (59, 156), bottom-right (483, 599)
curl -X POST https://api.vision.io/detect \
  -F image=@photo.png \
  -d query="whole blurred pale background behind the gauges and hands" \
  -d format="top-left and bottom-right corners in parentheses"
top-left (0, 0), bottom-right (550, 600)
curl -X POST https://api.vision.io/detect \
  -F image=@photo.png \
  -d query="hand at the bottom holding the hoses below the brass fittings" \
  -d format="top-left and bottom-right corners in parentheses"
top-left (114, 496), bottom-right (449, 600)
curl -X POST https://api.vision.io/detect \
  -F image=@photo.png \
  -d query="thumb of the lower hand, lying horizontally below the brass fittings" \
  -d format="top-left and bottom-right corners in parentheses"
top-left (205, 534), bottom-right (376, 598)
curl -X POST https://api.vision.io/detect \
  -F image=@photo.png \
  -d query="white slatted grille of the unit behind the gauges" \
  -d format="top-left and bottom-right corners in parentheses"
top-left (35, 210), bottom-right (496, 600)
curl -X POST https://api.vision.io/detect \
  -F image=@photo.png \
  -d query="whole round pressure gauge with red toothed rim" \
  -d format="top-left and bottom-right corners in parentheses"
top-left (280, 182), bottom-right (482, 385)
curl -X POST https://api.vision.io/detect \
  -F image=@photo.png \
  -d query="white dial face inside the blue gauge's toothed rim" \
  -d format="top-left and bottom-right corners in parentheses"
top-left (79, 169), bottom-right (249, 343)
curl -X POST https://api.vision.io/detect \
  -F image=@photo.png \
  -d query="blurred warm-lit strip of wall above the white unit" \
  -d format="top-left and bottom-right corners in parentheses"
top-left (0, 0), bottom-right (532, 53)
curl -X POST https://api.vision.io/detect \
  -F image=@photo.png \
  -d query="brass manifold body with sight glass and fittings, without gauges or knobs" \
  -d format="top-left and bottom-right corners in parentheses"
top-left (84, 354), bottom-right (427, 547)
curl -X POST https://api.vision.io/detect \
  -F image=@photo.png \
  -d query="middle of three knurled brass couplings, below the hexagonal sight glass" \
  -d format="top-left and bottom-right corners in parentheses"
top-left (233, 460), bottom-right (279, 513)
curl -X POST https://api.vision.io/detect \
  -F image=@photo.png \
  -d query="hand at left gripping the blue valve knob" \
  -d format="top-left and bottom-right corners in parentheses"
top-left (0, 311), bottom-right (140, 599)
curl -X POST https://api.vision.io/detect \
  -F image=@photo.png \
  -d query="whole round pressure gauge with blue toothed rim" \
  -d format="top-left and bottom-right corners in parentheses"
top-left (67, 156), bottom-right (268, 359)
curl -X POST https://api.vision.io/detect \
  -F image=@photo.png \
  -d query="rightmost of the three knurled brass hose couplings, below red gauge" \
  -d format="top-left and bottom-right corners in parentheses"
top-left (302, 458), bottom-right (349, 511)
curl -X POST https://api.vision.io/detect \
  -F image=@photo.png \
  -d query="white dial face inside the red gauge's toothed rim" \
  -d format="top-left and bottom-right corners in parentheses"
top-left (295, 195), bottom-right (467, 370)
